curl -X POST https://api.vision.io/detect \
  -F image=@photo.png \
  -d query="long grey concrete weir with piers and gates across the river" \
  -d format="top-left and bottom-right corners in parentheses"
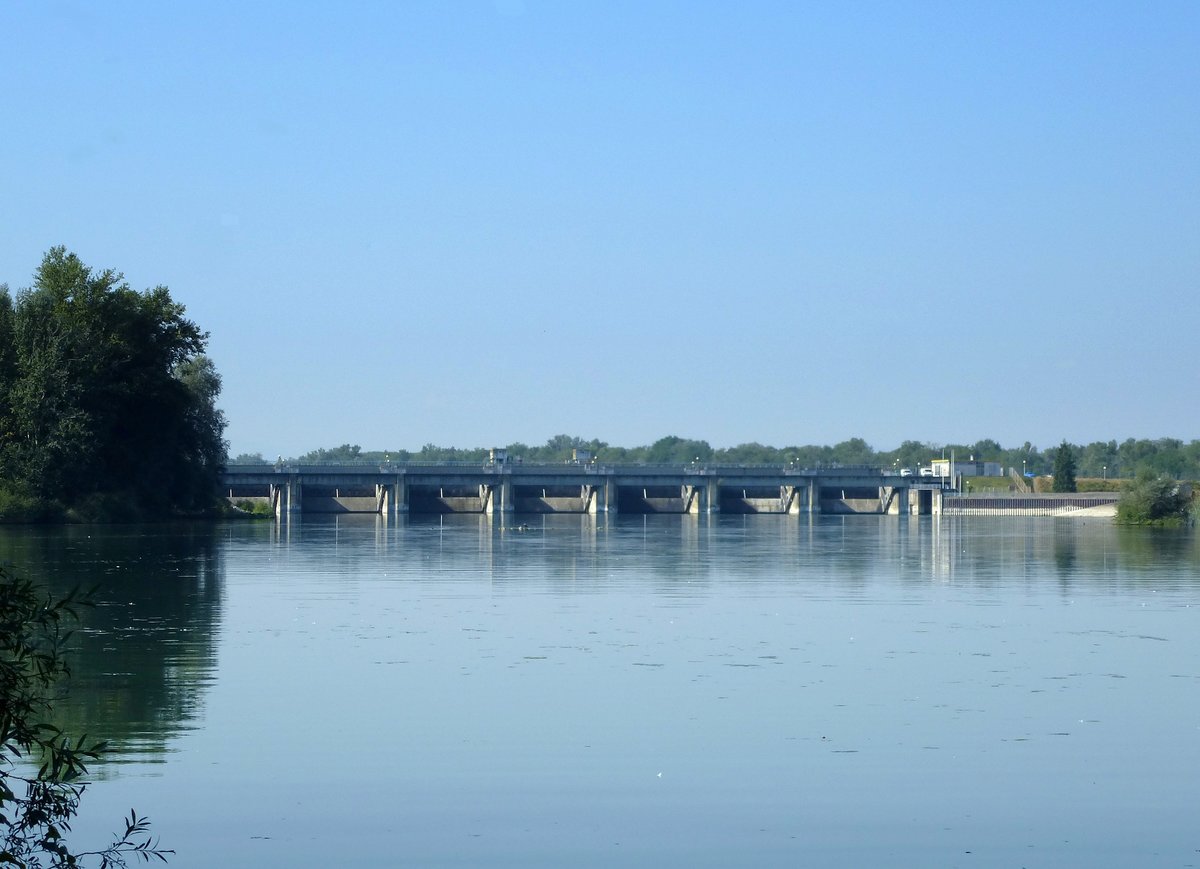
top-left (224, 461), bottom-right (946, 516)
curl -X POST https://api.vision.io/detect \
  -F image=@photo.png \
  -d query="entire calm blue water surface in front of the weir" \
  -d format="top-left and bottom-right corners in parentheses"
top-left (0, 516), bottom-right (1200, 868)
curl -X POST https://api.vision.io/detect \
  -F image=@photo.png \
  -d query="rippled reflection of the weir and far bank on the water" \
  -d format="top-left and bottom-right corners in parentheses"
top-left (258, 515), bottom-right (1200, 594)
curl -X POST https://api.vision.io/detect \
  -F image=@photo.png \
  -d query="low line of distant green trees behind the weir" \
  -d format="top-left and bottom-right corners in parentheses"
top-left (233, 435), bottom-right (1200, 480)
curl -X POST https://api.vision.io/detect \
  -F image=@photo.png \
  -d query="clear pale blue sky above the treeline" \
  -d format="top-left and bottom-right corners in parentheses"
top-left (0, 0), bottom-right (1200, 455)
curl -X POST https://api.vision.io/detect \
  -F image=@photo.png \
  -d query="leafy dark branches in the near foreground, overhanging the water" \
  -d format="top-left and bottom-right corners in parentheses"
top-left (0, 567), bottom-right (174, 869)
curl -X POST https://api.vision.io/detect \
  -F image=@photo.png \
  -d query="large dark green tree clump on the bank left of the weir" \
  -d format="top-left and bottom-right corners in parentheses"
top-left (0, 247), bottom-right (226, 517)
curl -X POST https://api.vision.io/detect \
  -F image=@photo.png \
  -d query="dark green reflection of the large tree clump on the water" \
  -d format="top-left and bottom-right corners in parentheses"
top-left (0, 525), bottom-right (224, 762)
